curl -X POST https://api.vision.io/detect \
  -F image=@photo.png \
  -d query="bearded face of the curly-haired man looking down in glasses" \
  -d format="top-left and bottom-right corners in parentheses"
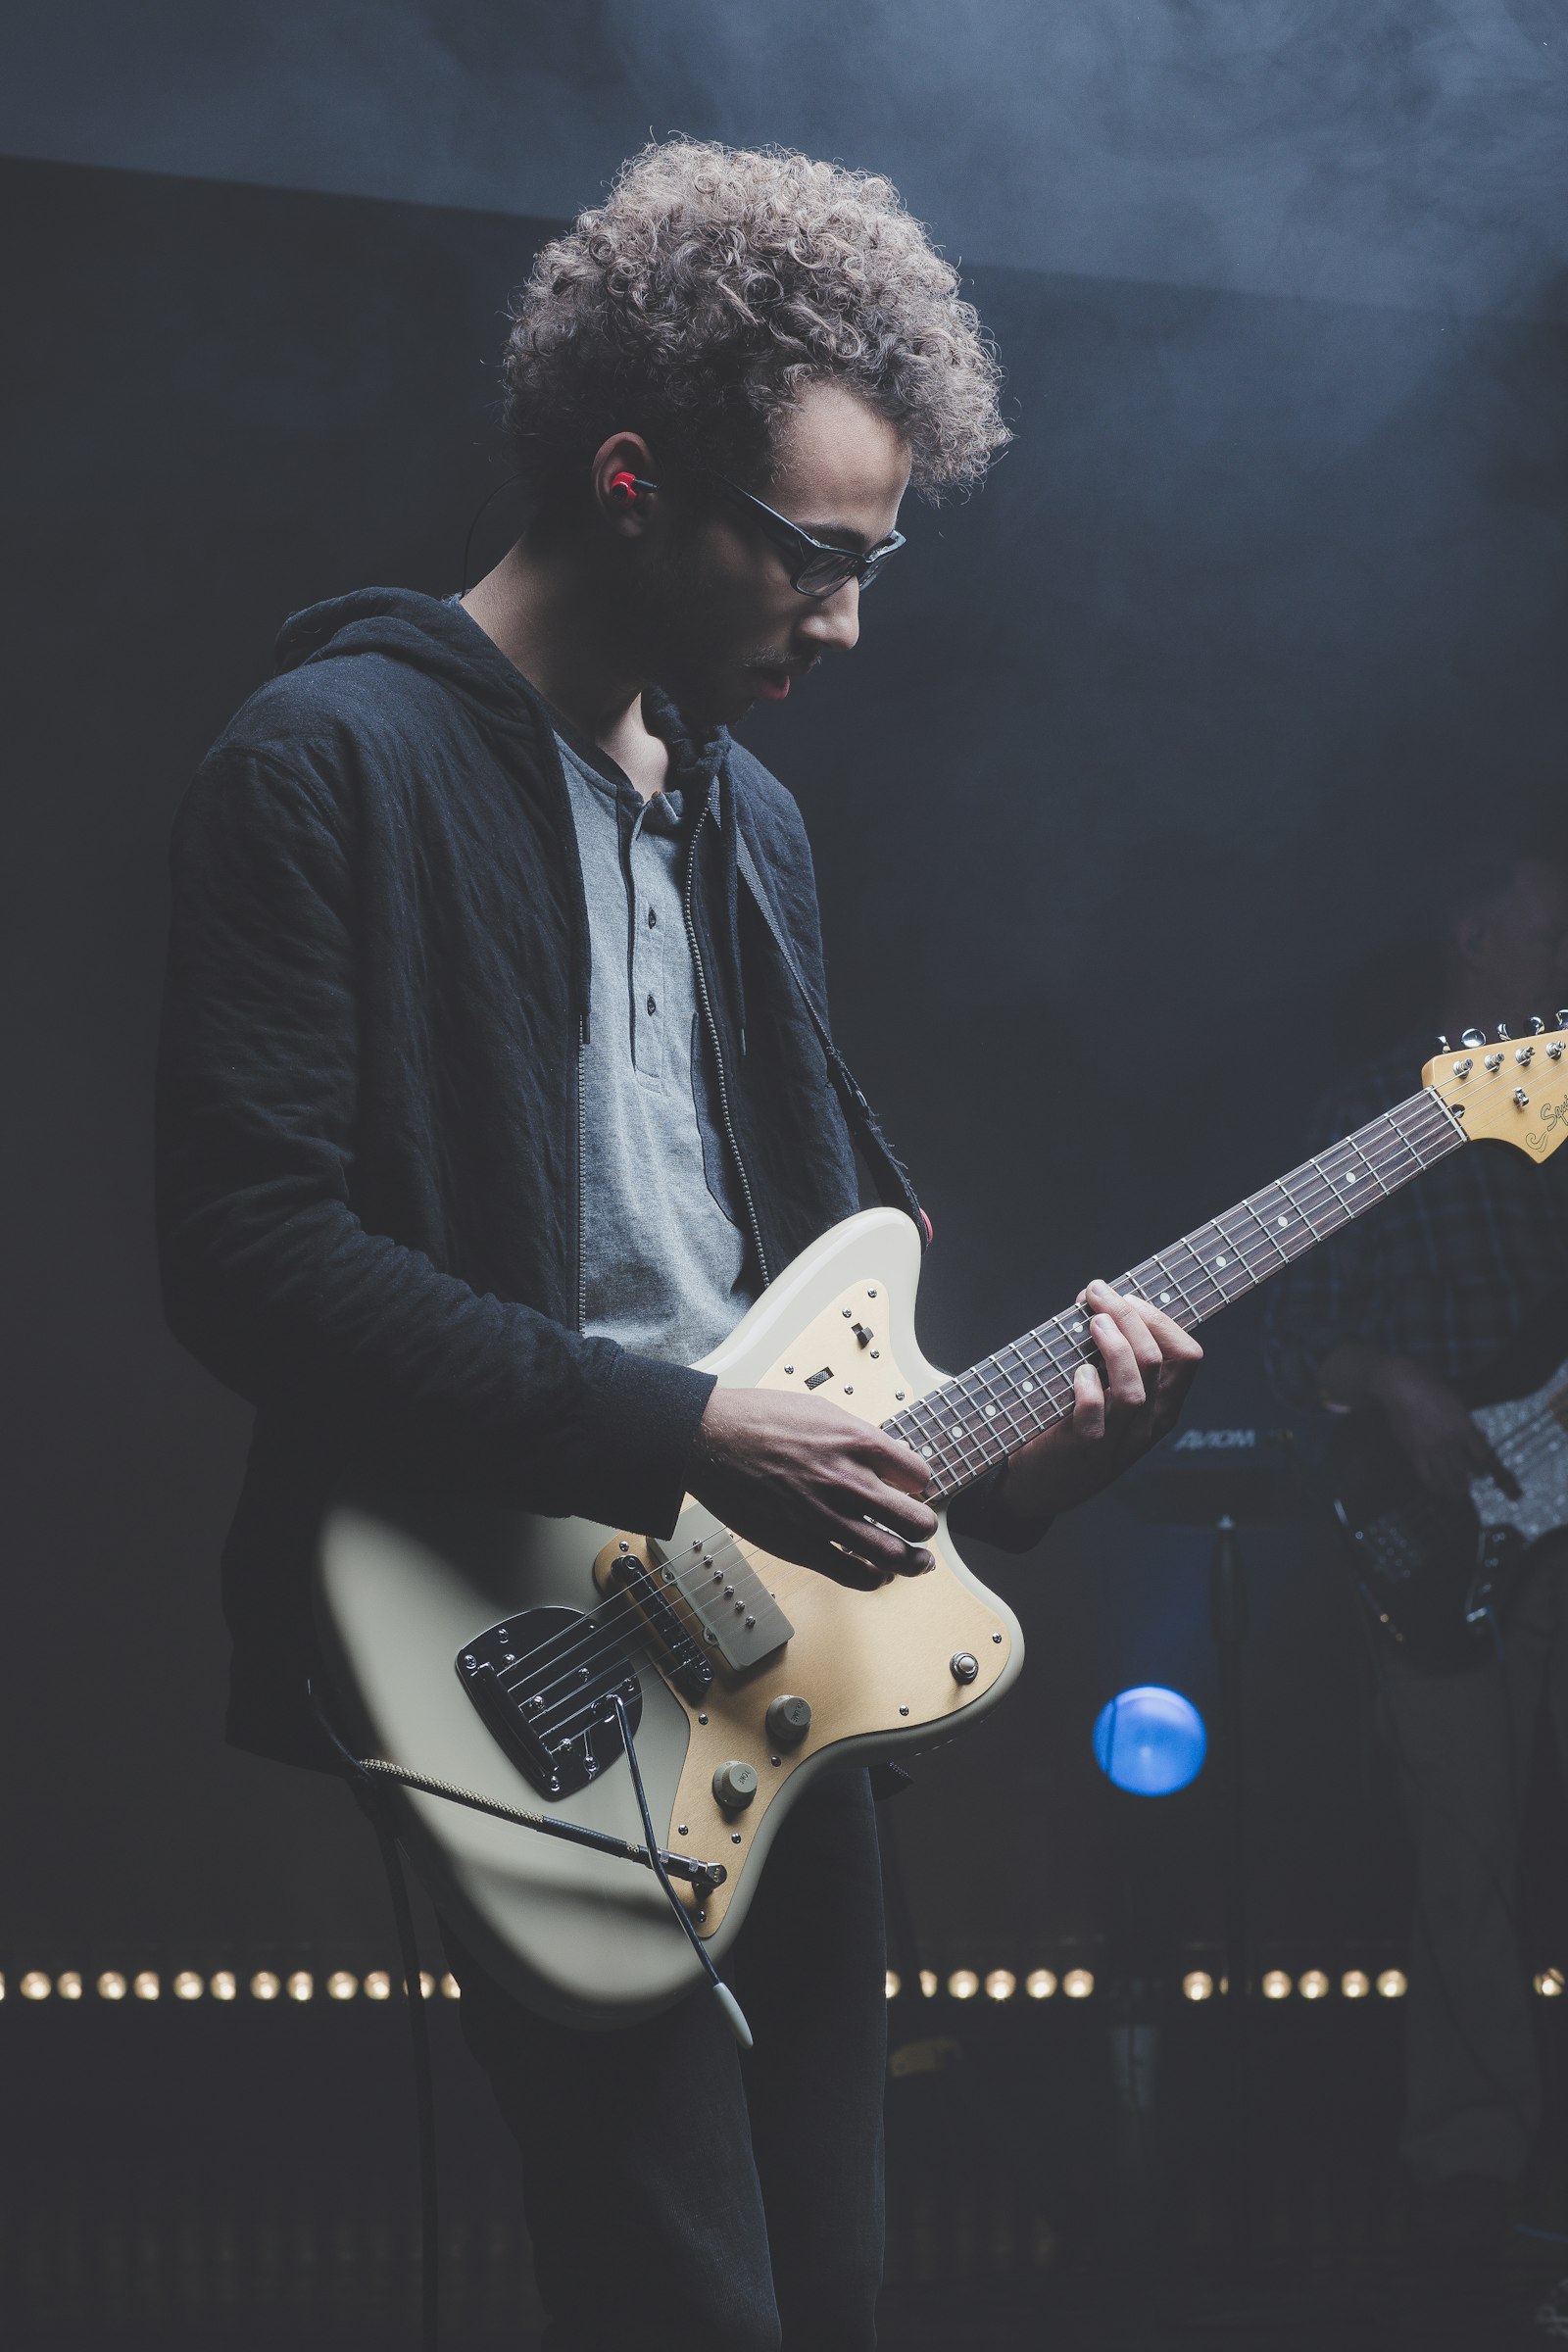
top-left (630, 383), bottom-right (909, 727)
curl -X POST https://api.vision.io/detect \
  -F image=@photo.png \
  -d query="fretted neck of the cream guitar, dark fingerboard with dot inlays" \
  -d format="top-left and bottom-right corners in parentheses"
top-left (882, 1089), bottom-right (1464, 1503)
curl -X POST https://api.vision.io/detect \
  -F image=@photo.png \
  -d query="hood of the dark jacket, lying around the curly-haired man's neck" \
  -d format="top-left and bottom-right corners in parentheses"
top-left (275, 588), bottom-right (729, 798)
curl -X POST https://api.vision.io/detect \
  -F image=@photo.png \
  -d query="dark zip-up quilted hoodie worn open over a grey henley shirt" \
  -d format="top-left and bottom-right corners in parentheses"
top-left (158, 588), bottom-right (906, 1762)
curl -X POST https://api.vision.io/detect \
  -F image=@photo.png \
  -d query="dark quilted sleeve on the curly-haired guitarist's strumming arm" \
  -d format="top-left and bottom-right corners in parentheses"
top-left (158, 746), bottom-right (712, 1534)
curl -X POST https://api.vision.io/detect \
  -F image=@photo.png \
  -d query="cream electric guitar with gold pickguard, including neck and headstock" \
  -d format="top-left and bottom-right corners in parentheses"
top-left (315, 1013), bottom-right (1568, 2025)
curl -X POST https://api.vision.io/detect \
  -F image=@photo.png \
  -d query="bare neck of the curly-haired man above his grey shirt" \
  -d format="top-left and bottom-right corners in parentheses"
top-left (464, 539), bottom-right (670, 800)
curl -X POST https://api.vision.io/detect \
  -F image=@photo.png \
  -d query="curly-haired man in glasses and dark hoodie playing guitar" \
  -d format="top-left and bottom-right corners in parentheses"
top-left (160, 141), bottom-right (1199, 2352)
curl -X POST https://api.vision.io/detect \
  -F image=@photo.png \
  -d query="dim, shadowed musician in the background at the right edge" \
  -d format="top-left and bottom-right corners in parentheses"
top-left (1265, 858), bottom-right (1568, 2253)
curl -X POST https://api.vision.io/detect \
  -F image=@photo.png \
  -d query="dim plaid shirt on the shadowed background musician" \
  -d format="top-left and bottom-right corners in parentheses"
top-left (1262, 1040), bottom-right (1568, 1411)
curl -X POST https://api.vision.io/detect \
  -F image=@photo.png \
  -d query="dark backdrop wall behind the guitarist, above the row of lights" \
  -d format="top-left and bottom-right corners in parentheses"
top-left (0, 147), bottom-right (1568, 1969)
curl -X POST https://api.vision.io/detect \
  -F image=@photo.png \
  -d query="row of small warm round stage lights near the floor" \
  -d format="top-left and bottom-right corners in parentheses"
top-left (12, 1969), bottom-right (1568, 2001)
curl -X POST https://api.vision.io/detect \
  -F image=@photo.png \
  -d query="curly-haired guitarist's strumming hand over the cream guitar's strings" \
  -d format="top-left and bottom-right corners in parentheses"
top-left (686, 1388), bottom-right (936, 1592)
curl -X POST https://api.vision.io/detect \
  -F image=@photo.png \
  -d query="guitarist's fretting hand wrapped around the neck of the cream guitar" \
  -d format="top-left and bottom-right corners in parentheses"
top-left (995, 1282), bottom-right (1203, 1527)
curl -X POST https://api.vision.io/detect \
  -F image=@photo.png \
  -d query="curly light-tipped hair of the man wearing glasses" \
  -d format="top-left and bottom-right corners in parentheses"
top-left (503, 139), bottom-right (1013, 513)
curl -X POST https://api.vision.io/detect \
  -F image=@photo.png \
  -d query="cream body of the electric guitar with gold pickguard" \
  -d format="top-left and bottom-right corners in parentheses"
top-left (315, 1209), bottom-right (1022, 2028)
